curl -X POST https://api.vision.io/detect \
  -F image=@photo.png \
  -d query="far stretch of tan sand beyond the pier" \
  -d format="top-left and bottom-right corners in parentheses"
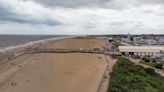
top-left (40, 38), bottom-right (104, 49)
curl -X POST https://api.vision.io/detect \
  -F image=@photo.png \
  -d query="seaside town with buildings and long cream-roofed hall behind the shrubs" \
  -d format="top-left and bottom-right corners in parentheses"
top-left (100, 34), bottom-right (164, 69)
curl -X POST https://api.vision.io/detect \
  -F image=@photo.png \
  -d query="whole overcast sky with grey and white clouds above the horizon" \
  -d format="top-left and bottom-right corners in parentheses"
top-left (0, 0), bottom-right (164, 34)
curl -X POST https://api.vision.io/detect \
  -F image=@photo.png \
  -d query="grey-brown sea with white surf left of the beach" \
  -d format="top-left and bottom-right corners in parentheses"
top-left (0, 35), bottom-right (66, 51)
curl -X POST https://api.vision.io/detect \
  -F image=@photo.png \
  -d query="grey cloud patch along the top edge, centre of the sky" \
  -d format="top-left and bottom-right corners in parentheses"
top-left (25, 0), bottom-right (114, 8)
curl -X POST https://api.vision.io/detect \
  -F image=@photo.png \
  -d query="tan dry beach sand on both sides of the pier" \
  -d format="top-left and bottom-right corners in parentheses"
top-left (0, 39), bottom-right (107, 92)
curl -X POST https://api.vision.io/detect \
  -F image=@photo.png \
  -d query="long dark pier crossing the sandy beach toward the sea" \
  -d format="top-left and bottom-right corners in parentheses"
top-left (0, 44), bottom-right (119, 64)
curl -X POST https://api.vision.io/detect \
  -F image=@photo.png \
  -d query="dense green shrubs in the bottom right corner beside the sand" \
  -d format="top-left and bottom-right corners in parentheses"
top-left (108, 55), bottom-right (164, 92)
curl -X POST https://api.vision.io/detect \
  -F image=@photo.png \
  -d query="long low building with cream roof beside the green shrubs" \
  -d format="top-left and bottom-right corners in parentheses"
top-left (119, 46), bottom-right (164, 56)
